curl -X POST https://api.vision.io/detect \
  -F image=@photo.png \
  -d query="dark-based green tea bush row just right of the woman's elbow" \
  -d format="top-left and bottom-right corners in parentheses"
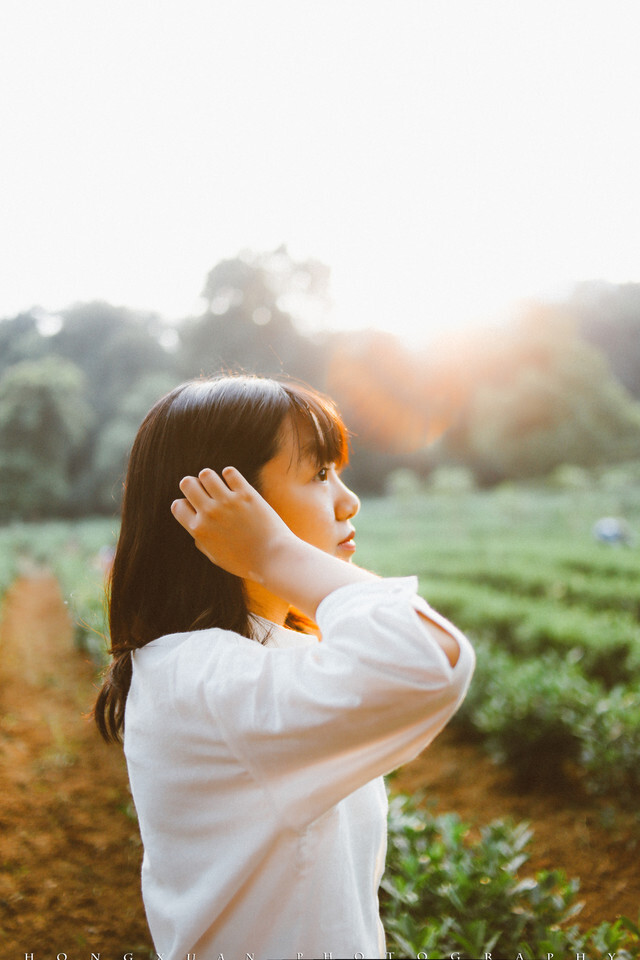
top-left (456, 643), bottom-right (640, 804)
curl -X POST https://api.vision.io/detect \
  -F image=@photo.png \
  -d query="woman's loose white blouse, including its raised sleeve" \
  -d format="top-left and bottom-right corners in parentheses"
top-left (124, 578), bottom-right (474, 960)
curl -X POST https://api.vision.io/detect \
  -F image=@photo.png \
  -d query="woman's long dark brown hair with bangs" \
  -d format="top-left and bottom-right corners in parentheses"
top-left (94, 376), bottom-right (348, 741)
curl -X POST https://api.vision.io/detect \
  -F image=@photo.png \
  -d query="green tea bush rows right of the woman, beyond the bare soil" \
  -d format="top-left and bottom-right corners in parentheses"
top-left (357, 489), bottom-right (640, 801)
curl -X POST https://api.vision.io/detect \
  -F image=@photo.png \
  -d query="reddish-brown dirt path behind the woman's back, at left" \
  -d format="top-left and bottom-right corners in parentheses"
top-left (0, 575), bottom-right (151, 960)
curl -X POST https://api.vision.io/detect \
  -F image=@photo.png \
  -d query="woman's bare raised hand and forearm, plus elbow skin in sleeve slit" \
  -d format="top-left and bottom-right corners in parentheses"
top-left (171, 467), bottom-right (459, 666)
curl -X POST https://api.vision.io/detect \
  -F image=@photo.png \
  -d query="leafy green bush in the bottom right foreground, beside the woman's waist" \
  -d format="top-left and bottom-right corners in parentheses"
top-left (381, 795), bottom-right (640, 960)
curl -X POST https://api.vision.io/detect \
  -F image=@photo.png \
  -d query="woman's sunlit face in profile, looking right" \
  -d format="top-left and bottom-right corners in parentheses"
top-left (260, 419), bottom-right (360, 561)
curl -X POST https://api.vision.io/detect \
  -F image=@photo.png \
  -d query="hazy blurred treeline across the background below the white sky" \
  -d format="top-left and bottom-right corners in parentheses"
top-left (0, 247), bottom-right (640, 521)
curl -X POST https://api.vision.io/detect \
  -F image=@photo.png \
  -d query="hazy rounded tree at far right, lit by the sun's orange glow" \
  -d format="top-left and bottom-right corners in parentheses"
top-left (444, 305), bottom-right (640, 483)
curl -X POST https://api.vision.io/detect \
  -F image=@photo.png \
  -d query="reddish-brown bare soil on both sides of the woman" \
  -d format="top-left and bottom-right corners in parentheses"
top-left (0, 572), bottom-right (640, 960)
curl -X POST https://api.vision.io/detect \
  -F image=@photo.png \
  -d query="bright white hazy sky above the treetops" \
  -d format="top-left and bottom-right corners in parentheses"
top-left (0, 0), bottom-right (640, 337)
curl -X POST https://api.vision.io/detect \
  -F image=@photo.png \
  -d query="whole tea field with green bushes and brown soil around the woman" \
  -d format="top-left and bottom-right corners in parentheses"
top-left (0, 484), bottom-right (640, 960)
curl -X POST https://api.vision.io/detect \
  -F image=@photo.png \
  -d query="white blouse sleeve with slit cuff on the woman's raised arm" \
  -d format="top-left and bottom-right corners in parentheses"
top-left (206, 578), bottom-right (475, 826)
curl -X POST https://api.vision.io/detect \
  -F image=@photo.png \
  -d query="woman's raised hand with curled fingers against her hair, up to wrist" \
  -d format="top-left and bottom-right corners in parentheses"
top-left (171, 467), bottom-right (297, 583)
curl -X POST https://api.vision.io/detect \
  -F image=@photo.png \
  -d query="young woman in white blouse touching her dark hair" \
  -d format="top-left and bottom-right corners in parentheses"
top-left (95, 377), bottom-right (474, 960)
